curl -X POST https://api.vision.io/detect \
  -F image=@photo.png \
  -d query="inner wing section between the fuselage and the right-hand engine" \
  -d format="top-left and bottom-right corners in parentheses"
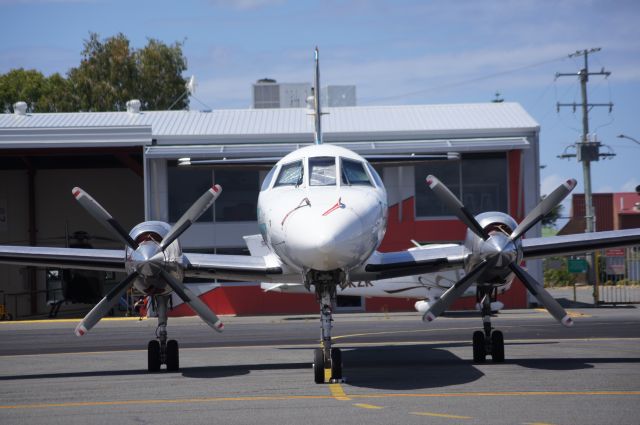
top-left (350, 245), bottom-right (469, 281)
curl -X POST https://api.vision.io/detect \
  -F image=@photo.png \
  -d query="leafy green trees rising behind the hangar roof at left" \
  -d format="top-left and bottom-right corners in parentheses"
top-left (0, 33), bottom-right (189, 112)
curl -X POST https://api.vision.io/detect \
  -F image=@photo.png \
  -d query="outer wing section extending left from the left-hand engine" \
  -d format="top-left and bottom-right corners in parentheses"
top-left (0, 245), bottom-right (125, 272)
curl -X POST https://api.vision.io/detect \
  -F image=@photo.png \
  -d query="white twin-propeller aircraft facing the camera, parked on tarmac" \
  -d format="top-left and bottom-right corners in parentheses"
top-left (0, 49), bottom-right (640, 383)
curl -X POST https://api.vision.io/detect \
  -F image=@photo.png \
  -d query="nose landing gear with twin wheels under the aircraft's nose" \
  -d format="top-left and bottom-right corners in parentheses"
top-left (313, 283), bottom-right (342, 384)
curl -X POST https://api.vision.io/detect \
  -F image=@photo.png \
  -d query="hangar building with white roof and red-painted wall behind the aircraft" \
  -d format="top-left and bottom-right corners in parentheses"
top-left (0, 102), bottom-right (542, 316)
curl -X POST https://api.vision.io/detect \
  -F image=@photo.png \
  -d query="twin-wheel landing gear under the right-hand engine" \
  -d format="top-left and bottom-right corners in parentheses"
top-left (473, 287), bottom-right (504, 363)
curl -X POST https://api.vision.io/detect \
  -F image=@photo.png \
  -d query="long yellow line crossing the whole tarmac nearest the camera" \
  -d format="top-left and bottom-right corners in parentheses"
top-left (0, 391), bottom-right (640, 413)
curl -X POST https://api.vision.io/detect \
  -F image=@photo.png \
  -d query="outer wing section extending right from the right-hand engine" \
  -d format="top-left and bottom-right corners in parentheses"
top-left (522, 229), bottom-right (640, 260)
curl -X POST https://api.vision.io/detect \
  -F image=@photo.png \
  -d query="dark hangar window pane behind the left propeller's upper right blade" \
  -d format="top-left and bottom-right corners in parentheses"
top-left (167, 165), bottom-right (213, 223)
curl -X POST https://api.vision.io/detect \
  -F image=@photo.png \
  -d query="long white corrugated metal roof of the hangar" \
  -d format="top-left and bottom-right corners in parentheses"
top-left (0, 102), bottom-right (539, 149)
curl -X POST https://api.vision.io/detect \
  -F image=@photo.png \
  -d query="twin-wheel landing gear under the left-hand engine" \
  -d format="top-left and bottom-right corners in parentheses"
top-left (147, 295), bottom-right (180, 372)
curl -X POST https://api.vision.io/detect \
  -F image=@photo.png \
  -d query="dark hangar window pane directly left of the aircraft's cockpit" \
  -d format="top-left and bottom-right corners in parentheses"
top-left (214, 168), bottom-right (260, 221)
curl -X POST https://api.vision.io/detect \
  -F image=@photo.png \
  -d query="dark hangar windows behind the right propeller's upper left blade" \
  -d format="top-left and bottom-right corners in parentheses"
top-left (415, 153), bottom-right (508, 217)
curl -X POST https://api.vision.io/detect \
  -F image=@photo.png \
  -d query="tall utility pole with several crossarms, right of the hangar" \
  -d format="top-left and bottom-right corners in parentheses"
top-left (556, 47), bottom-right (615, 303)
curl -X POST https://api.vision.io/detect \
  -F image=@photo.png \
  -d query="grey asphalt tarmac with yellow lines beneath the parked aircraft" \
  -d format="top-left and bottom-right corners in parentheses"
top-left (0, 307), bottom-right (640, 425)
